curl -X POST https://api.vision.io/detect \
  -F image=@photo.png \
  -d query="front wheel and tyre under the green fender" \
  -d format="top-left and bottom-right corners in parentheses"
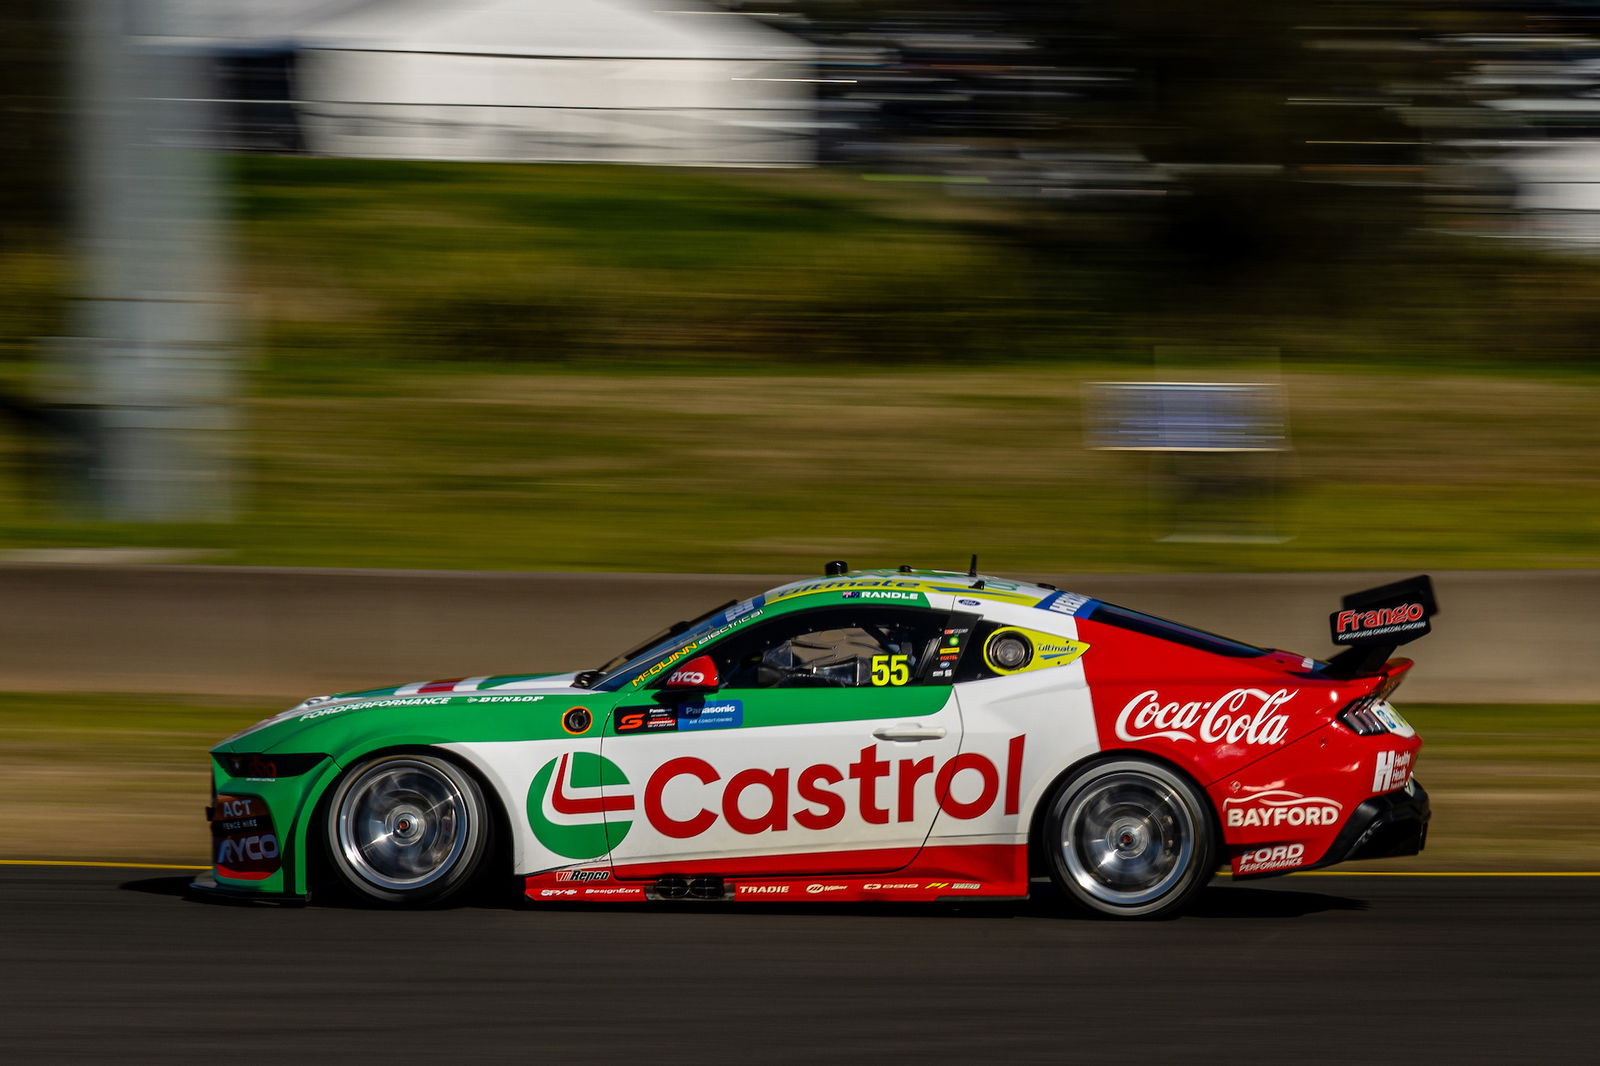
top-left (325, 752), bottom-right (493, 906)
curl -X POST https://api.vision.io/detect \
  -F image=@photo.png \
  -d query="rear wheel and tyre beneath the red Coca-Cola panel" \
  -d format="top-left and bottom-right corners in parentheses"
top-left (1040, 759), bottom-right (1218, 919)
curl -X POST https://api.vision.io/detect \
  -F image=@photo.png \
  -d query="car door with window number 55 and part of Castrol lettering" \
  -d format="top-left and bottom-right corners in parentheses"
top-left (602, 605), bottom-right (960, 879)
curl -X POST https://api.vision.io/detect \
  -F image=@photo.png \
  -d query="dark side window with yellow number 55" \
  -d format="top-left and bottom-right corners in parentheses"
top-left (712, 607), bottom-right (949, 688)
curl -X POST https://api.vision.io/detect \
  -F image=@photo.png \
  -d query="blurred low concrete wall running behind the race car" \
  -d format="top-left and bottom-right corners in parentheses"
top-left (0, 565), bottom-right (1600, 703)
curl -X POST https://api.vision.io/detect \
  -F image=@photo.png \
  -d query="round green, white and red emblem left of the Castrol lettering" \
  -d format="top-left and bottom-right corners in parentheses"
top-left (528, 751), bottom-right (634, 860)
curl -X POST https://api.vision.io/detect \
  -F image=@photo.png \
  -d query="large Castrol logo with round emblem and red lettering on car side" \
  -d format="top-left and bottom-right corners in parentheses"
top-left (528, 736), bottom-right (1027, 860)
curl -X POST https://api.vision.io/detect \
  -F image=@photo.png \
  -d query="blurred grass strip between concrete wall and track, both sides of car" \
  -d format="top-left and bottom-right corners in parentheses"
top-left (0, 693), bottom-right (1600, 871)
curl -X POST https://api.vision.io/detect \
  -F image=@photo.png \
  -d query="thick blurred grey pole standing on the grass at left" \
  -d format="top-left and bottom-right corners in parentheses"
top-left (68, 0), bottom-right (234, 522)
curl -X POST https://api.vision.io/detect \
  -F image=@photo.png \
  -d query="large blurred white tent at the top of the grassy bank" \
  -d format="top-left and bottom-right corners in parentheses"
top-left (294, 0), bottom-right (814, 165)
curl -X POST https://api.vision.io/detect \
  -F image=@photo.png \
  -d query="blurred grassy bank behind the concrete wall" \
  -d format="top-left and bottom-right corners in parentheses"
top-left (0, 157), bottom-right (1600, 573)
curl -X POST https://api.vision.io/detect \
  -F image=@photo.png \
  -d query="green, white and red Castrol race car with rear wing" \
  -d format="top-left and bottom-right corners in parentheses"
top-left (200, 560), bottom-right (1437, 917)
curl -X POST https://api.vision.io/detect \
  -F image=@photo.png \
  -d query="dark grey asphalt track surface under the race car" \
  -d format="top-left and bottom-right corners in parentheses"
top-left (0, 866), bottom-right (1600, 1066)
